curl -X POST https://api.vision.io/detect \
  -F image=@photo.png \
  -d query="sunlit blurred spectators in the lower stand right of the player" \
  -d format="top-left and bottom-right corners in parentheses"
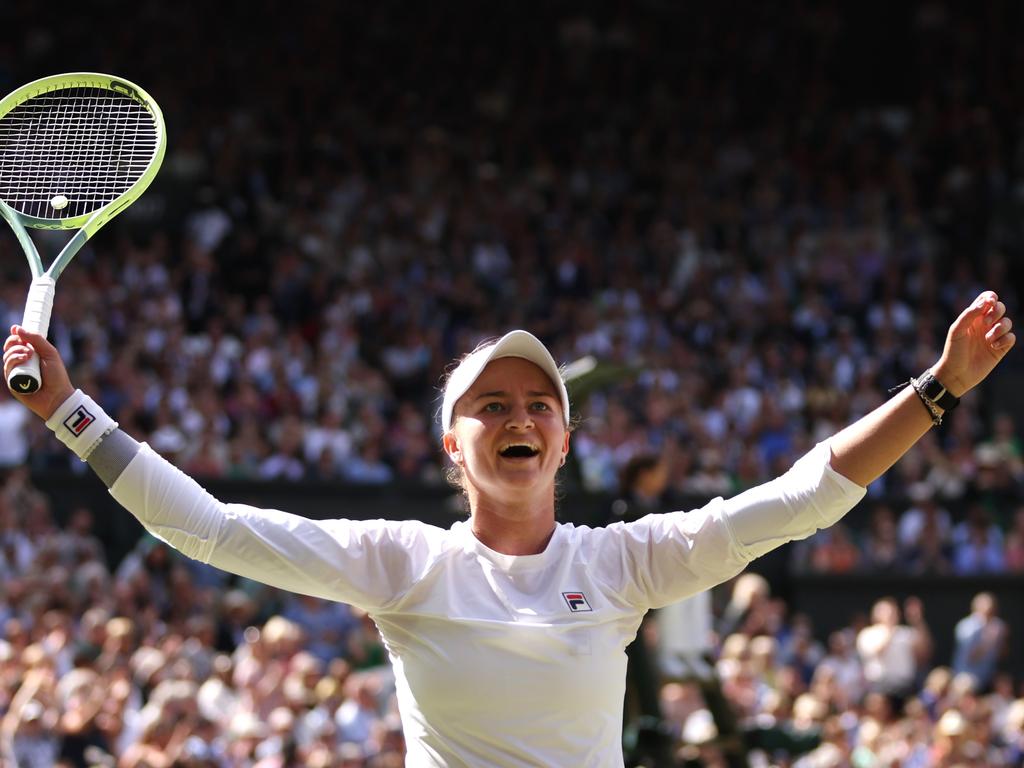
top-left (647, 574), bottom-right (1024, 768)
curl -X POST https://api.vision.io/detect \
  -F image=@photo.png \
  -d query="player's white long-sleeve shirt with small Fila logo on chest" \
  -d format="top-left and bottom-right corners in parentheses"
top-left (111, 443), bottom-right (864, 768)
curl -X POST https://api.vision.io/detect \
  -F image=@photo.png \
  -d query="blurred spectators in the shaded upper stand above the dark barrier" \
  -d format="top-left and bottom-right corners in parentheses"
top-left (0, 3), bottom-right (1024, 512)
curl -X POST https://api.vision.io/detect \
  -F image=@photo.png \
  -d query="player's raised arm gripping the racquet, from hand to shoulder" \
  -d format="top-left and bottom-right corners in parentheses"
top-left (4, 326), bottom-right (443, 611)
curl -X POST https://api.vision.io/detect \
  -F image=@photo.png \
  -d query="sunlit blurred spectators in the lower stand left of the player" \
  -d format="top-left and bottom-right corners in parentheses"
top-left (0, 471), bottom-right (404, 768)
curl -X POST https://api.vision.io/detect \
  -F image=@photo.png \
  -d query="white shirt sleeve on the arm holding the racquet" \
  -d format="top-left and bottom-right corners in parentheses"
top-left (110, 443), bottom-right (444, 611)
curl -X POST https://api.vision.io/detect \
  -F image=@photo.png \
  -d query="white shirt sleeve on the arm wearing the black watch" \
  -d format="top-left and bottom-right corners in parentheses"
top-left (592, 442), bottom-right (865, 608)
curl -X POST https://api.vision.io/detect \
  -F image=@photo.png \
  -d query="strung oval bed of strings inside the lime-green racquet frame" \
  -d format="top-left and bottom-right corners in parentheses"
top-left (0, 87), bottom-right (160, 224)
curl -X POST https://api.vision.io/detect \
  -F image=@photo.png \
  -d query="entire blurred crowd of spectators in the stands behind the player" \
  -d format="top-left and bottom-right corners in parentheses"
top-left (0, 0), bottom-right (1024, 768)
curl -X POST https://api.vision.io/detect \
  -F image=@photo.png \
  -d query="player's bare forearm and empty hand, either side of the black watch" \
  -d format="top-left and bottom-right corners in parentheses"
top-left (830, 291), bottom-right (1016, 485)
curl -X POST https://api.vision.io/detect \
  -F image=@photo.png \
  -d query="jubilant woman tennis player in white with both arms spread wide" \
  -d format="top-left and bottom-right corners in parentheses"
top-left (4, 292), bottom-right (1015, 768)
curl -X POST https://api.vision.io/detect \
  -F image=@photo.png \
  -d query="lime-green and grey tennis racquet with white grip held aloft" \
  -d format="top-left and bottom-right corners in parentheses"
top-left (0, 72), bottom-right (167, 394)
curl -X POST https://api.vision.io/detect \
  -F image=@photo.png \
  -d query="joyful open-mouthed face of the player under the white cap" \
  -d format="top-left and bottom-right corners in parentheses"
top-left (444, 357), bottom-right (569, 503)
